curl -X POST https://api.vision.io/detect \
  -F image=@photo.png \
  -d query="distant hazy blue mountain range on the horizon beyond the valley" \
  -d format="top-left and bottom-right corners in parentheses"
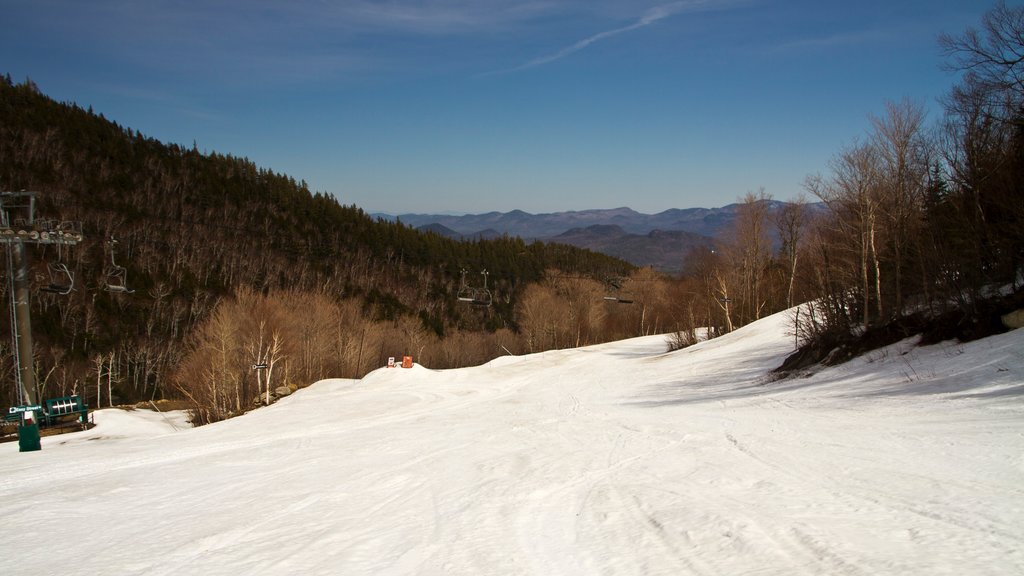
top-left (374, 201), bottom-right (798, 273)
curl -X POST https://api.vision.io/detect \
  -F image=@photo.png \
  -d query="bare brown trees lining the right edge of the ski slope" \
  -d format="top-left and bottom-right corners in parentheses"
top-left (676, 2), bottom-right (1024, 367)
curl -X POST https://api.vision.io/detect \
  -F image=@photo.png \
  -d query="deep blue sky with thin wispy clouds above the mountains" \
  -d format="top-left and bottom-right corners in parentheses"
top-left (0, 0), bottom-right (992, 213)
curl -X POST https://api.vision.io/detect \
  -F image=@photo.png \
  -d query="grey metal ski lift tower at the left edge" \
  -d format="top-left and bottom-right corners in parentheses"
top-left (0, 191), bottom-right (82, 406)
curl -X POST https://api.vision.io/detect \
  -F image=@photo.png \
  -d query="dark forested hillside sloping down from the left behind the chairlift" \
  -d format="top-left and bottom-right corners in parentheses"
top-left (0, 77), bottom-right (632, 416)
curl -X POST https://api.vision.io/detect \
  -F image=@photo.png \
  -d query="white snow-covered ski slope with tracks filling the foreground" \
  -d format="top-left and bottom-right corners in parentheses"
top-left (0, 315), bottom-right (1024, 576)
